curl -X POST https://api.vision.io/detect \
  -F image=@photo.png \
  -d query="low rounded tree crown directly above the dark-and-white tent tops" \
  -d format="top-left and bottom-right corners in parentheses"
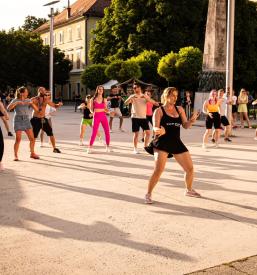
top-left (105, 60), bottom-right (142, 82)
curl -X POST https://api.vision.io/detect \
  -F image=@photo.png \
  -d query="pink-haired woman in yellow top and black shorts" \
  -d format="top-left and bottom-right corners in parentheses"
top-left (202, 90), bottom-right (221, 149)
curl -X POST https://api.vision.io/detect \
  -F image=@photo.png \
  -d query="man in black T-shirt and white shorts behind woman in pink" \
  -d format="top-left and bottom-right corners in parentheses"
top-left (107, 85), bottom-right (124, 132)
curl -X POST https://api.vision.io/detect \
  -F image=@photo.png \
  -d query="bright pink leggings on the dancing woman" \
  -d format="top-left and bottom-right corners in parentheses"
top-left (89, 112), bottom-right (110, 146)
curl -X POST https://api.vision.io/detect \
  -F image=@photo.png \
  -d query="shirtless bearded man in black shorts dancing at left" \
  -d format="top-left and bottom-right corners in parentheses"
top-left (30, 87), bottom-right (63, 153)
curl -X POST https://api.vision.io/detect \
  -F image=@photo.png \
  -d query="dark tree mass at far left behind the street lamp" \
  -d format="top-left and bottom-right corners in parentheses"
top-left (0, 30), bottom-right (71, 88)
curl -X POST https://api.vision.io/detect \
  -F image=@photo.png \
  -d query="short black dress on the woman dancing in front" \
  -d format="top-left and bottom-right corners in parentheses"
top-left (145, 106), bottom-right (188, 158)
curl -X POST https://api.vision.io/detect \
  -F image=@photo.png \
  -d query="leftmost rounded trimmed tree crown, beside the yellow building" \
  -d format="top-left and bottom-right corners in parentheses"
top-left (81, 64), bottom-right (109, 90)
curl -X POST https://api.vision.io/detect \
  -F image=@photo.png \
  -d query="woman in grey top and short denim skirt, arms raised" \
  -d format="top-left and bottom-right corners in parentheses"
top-left (7, 86), bottom-right (39, 161)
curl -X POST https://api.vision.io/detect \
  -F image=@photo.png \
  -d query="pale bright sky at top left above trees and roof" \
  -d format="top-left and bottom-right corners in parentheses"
top-left (0, 0), bottom-right (76, 30)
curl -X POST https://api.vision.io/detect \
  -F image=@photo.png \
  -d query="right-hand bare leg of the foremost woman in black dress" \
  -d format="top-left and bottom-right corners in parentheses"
top-left (174, 152), bottom-right (194, 191)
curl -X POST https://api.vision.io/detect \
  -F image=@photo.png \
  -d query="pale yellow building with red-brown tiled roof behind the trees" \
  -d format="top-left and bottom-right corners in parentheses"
top-left (36, 0), bottom-right (111, 100)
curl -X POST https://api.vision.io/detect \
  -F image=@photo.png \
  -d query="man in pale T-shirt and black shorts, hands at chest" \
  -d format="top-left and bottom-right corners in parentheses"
top-left (125, 83), bottom-right (154, 154)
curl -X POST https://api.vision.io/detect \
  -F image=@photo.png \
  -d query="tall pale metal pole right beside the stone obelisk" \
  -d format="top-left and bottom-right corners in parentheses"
top-left (226, 0), bottom-right (235, 134)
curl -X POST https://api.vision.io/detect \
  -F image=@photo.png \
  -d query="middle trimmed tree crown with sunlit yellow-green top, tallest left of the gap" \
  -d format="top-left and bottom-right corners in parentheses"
top-left (129, 50), bottom-right (161, 84)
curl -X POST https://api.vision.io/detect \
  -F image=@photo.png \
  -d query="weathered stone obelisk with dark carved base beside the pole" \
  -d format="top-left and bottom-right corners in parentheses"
top-left (195, 0), bottom-right (227, 112)
